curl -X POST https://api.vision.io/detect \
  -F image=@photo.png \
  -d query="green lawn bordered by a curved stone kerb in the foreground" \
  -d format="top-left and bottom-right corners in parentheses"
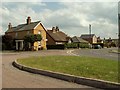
top-left (18, 56), bottom-right (118, 82)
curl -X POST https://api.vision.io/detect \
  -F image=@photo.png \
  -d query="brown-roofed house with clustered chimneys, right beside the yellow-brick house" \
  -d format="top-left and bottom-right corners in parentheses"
top-left (46, 26), bottom-right (70, 48)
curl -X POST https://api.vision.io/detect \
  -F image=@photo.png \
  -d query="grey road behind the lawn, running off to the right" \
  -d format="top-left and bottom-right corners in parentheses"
top-left (71, 48), bottom-right (120, 60)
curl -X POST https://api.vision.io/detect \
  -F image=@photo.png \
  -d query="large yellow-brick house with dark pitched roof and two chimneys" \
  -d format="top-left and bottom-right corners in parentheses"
top-left (5, 17), bottom-right (46, 50)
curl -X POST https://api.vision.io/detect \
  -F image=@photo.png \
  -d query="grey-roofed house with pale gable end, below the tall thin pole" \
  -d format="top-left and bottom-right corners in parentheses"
top-left (80, 34), bottom-right (97, 44)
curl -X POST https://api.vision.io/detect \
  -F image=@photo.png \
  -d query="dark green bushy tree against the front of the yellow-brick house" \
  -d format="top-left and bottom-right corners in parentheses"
top-left (24, 34), bottom-right (42, 50)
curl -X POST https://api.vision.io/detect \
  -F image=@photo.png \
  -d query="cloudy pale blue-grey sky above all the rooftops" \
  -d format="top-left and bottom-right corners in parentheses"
top-left (0, 0), bottom-right (119, 38)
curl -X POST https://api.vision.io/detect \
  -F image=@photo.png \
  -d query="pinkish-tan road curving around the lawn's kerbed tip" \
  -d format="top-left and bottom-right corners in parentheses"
top-left (1, 50), bottom-right (97, 88)
